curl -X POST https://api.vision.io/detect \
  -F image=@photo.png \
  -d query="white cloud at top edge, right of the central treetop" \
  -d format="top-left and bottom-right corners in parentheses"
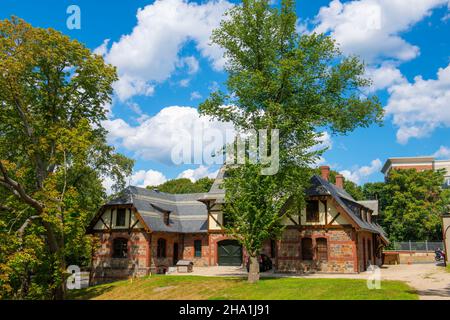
top-left (314, 0), bottom-right (448, 62)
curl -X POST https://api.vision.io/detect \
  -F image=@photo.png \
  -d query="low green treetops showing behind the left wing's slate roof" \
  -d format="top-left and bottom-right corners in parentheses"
top-left (147, 177), bottom-right (214, 194)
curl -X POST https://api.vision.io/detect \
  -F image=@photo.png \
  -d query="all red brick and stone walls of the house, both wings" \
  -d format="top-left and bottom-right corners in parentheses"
top-left (93, 227), bottom-right (380, 282)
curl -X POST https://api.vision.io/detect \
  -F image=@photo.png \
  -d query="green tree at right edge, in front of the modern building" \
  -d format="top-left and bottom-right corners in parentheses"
top-left (380, 170), bottom-right (450, 241)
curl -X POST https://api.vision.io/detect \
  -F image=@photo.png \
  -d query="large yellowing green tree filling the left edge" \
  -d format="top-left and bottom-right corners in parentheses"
top-left (0, 17), bottom-right (133, 299)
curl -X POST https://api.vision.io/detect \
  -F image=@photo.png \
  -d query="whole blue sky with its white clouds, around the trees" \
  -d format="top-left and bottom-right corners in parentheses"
top-left (0, 0), bottom-right (450, 185)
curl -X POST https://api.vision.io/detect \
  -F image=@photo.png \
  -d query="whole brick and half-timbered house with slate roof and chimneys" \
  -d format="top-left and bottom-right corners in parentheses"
top-left (89, 167), bottom-right (387, 282)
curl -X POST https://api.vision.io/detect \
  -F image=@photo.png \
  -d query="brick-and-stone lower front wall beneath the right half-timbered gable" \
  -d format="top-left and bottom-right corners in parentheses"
top-left (275, 228), bottom-right (357, 273)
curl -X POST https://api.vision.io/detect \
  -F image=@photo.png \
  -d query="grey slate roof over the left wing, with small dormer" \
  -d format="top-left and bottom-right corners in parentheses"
top-left (106, 186), bottom-right (208, 233)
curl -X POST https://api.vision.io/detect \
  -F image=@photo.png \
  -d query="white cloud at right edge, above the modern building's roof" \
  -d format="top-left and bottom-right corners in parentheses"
top-left (386, 65), bottom-right (450, 144)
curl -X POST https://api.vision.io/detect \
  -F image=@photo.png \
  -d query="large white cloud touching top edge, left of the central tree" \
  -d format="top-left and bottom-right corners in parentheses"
top-left (102, 0), bottom-right (232, 101)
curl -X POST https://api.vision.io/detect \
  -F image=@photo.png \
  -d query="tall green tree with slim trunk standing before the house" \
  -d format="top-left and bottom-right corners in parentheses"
top-left (200, 0), bottom-right (383, 281)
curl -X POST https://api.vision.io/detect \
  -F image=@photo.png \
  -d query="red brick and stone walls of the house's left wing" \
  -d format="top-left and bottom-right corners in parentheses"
top-left (93, 231), bottom-right (239, 282)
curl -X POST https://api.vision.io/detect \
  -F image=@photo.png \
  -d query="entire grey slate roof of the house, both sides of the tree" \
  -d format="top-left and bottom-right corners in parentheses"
top-left (100, 167), bottom-right (389, 242)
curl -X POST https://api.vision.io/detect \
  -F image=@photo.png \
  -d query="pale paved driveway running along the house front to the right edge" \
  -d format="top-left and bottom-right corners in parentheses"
top-left (174, 263), bottom-right (450, 300)
